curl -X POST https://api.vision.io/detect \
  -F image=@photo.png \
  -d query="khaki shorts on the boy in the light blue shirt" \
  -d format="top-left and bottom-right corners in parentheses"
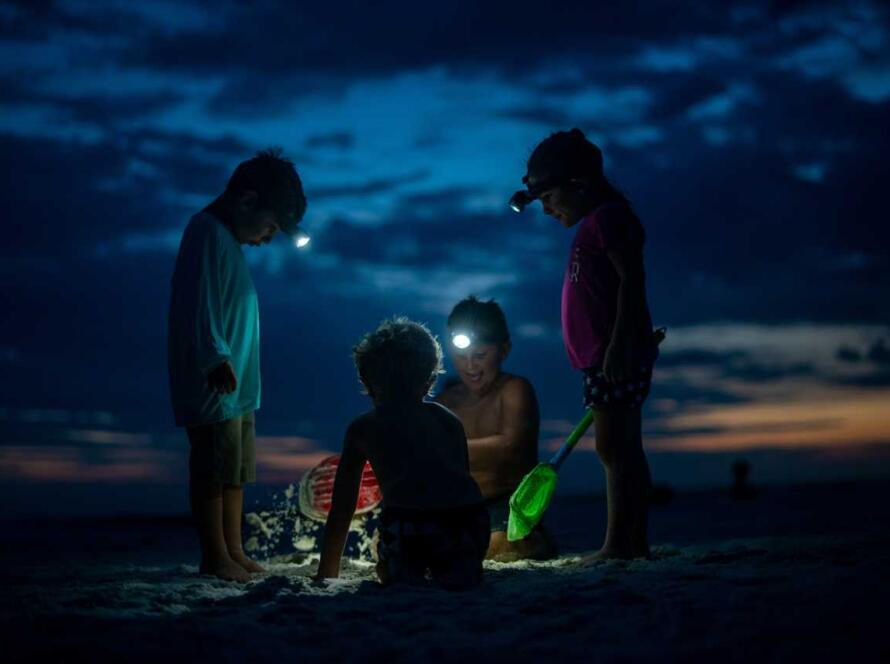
top-left (186, 412), bottom-right (256, 486)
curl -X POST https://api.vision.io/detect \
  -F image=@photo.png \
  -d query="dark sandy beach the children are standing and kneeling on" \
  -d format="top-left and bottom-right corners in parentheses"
top-left (2, 482), bottom-right (890, 662)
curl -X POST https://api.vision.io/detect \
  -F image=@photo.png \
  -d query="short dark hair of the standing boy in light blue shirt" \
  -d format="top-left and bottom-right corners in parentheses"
top-left (226, 148), bottom-right (306, 235)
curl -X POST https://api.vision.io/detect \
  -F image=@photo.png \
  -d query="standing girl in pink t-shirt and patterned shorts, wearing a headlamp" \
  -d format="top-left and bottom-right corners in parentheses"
top-left (511, 129), bottom-right (658, 560)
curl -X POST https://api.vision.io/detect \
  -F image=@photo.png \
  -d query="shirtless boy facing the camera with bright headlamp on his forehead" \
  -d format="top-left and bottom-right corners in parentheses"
top-left (436, 296), bottom-right (556, 562)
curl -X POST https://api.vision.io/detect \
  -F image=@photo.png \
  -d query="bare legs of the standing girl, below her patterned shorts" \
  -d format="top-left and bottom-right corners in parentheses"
top-left (585, 409), bottom-right (652, 561)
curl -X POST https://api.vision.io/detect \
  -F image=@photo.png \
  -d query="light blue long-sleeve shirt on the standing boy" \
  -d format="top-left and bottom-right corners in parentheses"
top-left (167, 212), bottom-right (260, 426)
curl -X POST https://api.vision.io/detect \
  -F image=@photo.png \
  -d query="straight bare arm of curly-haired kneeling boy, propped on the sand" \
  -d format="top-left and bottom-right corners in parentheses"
top-left (317, 423), bottom-right (367, 579)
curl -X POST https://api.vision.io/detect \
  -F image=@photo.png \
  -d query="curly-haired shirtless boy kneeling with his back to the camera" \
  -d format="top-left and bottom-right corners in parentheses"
top-left (318, 318), bottom-right (489, 590)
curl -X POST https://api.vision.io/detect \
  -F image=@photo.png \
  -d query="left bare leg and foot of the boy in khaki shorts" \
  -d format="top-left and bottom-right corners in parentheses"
top-left (189, 479), bottom-right (250, 583)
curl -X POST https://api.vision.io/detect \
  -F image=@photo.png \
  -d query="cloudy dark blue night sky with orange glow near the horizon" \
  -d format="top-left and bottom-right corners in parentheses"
top-left (0, 1), bottom-right (890, 513)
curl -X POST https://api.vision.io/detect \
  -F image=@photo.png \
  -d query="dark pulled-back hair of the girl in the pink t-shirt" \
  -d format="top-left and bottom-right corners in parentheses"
top-left (526, 127), bottom-right (645, 243)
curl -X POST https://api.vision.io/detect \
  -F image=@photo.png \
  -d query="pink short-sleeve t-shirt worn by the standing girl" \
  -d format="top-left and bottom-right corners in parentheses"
top-left (562, 202), bottom-right (652, 369)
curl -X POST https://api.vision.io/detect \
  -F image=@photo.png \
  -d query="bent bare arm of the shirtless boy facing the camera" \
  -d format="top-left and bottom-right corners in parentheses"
top-left (467, 378), bottom-right (540, 469)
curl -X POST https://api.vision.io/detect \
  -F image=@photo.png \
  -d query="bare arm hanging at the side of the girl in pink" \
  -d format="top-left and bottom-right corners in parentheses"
top-left (603, 249), bottom-right (647, 382)
